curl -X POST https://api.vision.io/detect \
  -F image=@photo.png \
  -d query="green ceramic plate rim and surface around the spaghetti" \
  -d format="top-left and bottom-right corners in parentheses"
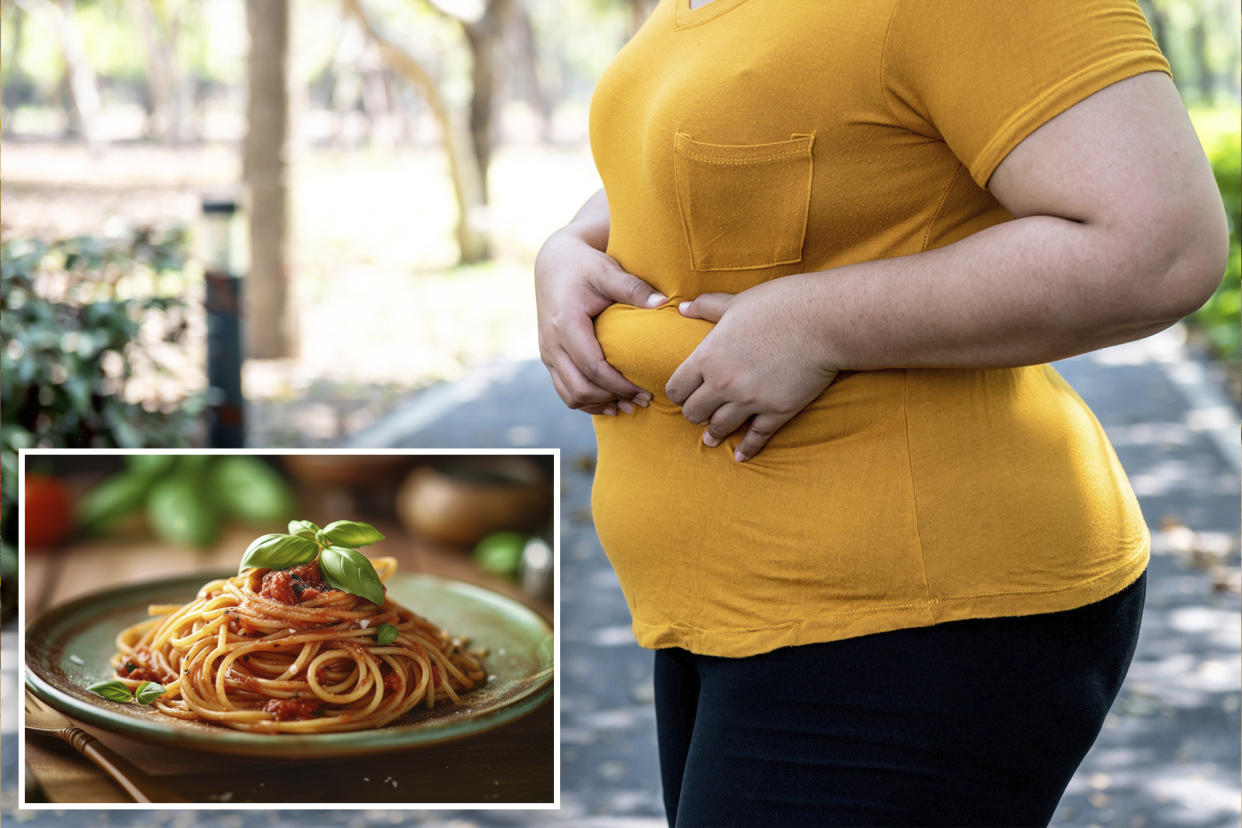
top-left (26, 572), bottom-right (554, 758)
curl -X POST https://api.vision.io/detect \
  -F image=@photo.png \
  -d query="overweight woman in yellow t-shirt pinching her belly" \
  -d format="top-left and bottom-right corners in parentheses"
top-left (535, 0), bottom-right (1227, 826)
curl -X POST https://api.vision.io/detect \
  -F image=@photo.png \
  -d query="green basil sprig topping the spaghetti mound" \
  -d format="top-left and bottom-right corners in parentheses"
top-left (237, 520), bottom-right (384, 607)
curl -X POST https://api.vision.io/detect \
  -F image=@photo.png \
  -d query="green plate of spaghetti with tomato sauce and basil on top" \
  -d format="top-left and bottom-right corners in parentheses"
top-left (26, 521), bottom-right (554, 757)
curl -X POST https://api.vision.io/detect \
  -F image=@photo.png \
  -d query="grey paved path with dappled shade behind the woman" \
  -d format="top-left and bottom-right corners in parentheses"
top-left (2, 334), bottom-right (1242, 828)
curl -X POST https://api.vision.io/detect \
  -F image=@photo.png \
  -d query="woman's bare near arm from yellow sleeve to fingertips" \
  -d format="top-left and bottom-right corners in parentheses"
top-left (666, 73), bottom-right (1228, 459)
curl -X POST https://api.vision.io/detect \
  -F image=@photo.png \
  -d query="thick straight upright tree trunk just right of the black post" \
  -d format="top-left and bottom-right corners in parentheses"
top-left (242, 0), bottom-right (297, 359)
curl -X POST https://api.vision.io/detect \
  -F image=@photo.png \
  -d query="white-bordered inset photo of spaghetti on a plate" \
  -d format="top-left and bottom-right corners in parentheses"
top-left (19, 449), bottom-right (559, 808)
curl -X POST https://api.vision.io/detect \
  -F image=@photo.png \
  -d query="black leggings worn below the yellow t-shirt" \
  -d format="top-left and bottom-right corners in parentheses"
top-left (656, 574), bottom-right (1146, 826)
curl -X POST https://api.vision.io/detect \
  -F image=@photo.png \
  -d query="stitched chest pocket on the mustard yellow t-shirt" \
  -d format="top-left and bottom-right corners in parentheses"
top-left (673, 133), bottom-right (815, 271)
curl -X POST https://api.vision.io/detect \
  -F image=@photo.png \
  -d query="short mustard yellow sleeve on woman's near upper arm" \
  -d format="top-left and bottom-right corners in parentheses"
top-left (883, 0), bottom-right (1169, 186)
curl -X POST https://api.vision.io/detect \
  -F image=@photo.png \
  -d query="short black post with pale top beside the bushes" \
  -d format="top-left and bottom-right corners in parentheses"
top-left (202, 199), bottom-right (246, 448)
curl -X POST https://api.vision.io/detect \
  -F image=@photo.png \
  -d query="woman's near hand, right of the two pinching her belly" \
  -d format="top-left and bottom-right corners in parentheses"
top-left (664, 286), bottom-right (837, 462)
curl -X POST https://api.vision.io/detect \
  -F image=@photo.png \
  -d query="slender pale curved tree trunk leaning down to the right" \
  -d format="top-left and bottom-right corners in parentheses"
top-left (344, 0), bottom-right (488, 263)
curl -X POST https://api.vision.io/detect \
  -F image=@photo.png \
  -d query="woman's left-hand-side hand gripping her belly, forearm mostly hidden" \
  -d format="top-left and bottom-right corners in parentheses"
top-left (535, 227), bottom-right (667, 416)
